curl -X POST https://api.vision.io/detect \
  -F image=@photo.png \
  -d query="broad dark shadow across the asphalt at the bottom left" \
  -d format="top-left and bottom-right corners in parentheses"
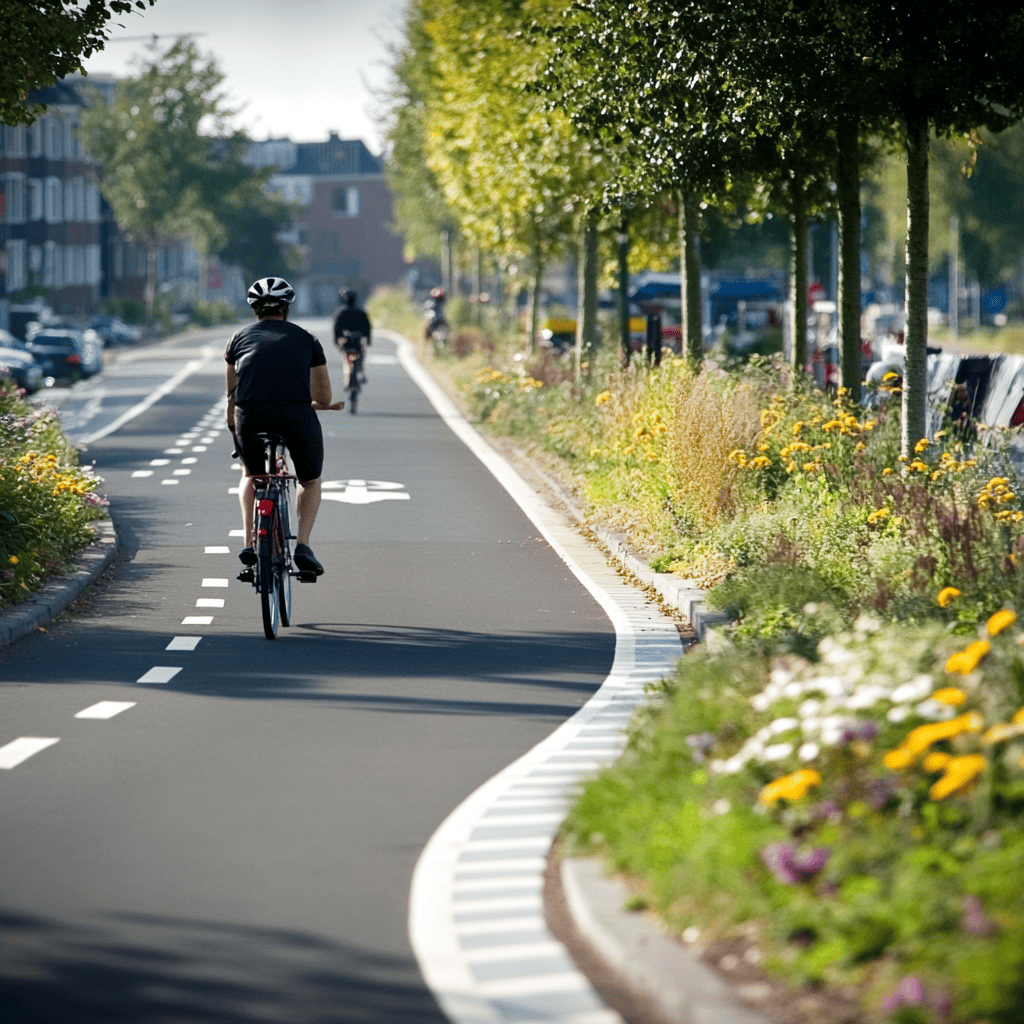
top-left (0, 910), bottom-right (446, 1024)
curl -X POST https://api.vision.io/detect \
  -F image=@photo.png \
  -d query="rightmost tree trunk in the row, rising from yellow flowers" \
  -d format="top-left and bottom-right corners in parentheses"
top-left (900, 115), bottom-right (929, 456)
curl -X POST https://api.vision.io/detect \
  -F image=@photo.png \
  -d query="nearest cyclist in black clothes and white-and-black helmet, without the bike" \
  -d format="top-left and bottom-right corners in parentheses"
top-left (224, 278), bottom-right (344, 575)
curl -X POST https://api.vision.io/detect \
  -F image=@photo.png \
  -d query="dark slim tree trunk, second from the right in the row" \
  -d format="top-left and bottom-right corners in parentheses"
top-left (836, 118), bottom-right (863, 404)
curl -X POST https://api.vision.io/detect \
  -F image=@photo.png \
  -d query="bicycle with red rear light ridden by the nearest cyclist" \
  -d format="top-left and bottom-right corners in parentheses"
top-left (239, 433), bottom-right (316, 640)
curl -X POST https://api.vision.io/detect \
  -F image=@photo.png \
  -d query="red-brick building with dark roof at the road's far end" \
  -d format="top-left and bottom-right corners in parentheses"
top-left (246, 132), bottom-right (406, 314)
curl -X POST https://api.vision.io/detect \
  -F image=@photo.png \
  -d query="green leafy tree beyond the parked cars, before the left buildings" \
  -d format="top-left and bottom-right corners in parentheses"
top-left (82, 39), bottom-right (288, 319)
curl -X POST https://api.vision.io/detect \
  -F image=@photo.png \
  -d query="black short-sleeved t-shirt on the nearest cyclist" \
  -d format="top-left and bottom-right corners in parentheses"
top-left (224, 319), bottom-right (327, 402)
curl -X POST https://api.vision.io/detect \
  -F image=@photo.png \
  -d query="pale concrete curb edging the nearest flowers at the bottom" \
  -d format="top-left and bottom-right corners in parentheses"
top-left (559, 857), bottom-right (768, 1024)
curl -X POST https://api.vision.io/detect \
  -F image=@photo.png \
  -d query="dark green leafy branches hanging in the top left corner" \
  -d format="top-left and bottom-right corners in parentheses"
top-left (0, 0), bottom-right (157, 125)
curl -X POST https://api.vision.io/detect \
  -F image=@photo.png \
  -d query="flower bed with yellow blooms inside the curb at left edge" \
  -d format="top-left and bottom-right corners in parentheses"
top-left (0, 377), bottom-right (108, 609)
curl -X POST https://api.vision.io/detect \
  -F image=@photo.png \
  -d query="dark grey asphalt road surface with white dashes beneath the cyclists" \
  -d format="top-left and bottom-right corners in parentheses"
top-left (0, 322), bottom-right (614, 1024)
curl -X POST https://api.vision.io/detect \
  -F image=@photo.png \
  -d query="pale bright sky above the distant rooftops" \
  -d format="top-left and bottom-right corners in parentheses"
top-left (84, 0), bottom-right (404, 154)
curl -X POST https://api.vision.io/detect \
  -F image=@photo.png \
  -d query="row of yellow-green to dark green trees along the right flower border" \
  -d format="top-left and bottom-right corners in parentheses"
top-left (389, 0), bottom-right (1024, 447)
